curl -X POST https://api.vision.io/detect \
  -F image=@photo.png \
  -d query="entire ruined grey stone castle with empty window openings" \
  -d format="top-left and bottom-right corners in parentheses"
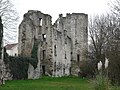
top-left (18, 10), bottom-right (88, 79)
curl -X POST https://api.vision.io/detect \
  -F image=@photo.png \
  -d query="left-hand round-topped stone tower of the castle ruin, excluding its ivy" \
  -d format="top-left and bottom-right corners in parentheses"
top-left (18, 10), bottom-right (52, 78)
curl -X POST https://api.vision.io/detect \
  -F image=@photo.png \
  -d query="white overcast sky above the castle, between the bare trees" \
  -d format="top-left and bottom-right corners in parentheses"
top-left (12, 0), bottom-right (113, 22)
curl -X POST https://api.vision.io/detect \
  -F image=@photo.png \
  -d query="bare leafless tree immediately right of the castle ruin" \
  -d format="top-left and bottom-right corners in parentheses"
top-left (89, 15), bottom-right (108, 61)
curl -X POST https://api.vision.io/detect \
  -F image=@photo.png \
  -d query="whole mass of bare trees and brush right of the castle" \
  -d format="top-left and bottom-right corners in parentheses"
top-left (89, 11), bottom-right (120, 84)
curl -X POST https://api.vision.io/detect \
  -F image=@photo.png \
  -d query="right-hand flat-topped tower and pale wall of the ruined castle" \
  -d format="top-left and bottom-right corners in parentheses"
top-left (53, 13), bottom-right (88, 75)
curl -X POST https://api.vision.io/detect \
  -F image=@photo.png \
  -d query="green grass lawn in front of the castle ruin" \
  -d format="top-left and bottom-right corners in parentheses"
top-left (0, 77), bottom-right (93, 90)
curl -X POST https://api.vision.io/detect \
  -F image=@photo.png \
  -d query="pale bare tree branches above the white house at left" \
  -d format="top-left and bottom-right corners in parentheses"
top-left (0, 0), bottom-right (19, 43)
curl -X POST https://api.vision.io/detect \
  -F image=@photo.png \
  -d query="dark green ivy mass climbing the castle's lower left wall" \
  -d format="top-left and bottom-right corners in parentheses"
top-left (4, 40), bottom-right (38, 79)
